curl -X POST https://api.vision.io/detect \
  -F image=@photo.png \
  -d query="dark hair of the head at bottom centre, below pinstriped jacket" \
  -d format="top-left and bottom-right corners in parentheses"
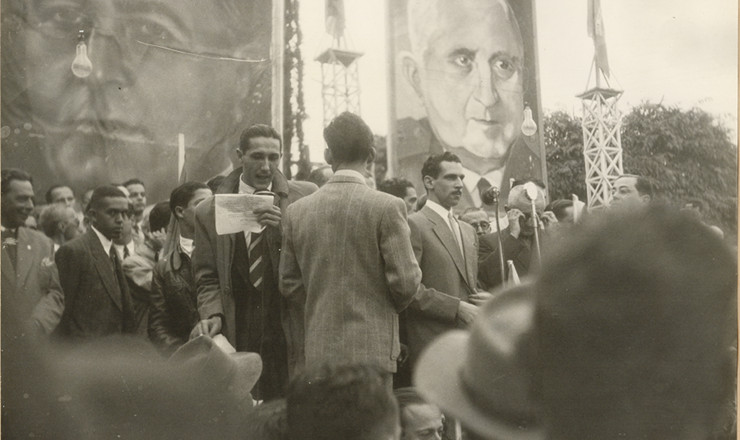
top-left (287, 365), bottom-right (398, 440)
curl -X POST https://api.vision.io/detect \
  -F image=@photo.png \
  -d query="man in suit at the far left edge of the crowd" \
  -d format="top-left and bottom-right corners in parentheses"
top-left (0, 168), bottom-right (64, 338)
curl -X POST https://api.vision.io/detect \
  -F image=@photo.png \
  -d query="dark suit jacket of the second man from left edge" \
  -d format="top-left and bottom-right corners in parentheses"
top-left (56, 228), bottom-right (134, 338)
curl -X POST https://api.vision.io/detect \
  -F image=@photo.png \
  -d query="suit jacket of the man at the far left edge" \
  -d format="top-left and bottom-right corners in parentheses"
top-left (0, 227), bottom-right (64, 333)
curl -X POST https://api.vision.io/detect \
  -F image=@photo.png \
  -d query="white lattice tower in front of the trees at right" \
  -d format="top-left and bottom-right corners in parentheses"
top-left (578, 80), bottom-right (624, 209)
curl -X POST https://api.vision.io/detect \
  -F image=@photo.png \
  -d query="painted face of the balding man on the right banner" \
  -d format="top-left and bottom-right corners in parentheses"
top-left (404, 0), bottom-right (523, 168)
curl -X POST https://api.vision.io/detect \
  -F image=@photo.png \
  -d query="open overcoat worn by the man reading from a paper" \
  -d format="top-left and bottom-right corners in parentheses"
top-left (192, 168), bottom-right (317, 371)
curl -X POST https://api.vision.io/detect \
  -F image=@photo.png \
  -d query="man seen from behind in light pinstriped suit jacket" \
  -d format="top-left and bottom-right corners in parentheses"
top-left (280, 112), bottom-right (421, 385)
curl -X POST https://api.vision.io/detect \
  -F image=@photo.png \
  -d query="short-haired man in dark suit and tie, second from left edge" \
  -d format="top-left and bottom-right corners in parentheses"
top-left (56, 185), bottom-right (136, 339)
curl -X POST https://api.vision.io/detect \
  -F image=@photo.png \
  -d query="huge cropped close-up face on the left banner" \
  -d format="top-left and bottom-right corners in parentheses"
top-left (3, 0), bottom-right (271, 201)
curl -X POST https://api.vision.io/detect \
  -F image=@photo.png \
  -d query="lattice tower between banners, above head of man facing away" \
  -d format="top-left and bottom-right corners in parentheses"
top-left (316, 48), bottom-right (363, 126)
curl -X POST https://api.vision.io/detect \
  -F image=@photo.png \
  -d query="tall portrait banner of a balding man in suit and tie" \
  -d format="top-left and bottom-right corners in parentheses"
top-left (388, 0), bottom-right (546, 210)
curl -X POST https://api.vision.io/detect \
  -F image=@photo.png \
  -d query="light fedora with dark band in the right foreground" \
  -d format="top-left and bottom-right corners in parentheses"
top-left (414, 284), bottom-right (544, 440)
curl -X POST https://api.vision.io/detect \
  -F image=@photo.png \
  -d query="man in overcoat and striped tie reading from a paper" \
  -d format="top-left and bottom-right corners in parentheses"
top-left (191, 125), bottom-right (317, 400)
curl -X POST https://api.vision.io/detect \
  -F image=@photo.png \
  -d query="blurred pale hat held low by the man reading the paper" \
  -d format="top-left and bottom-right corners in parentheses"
top-left (169, 335), bottom-right (262, 401)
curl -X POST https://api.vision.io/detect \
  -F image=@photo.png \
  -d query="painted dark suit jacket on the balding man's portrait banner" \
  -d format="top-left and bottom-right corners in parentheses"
top-left (396, 118), bottom-right (542, 213)
